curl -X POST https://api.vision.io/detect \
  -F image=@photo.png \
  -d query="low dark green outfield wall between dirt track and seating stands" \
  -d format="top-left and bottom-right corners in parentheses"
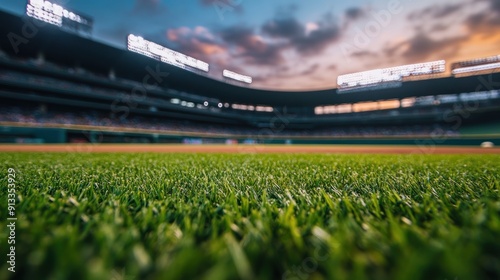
top-left (0, 126), bottom-right (500, 146)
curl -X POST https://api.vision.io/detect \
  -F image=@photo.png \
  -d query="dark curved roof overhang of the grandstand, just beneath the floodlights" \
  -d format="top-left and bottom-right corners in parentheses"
top-left (0, 11), bottom-right (498, 107)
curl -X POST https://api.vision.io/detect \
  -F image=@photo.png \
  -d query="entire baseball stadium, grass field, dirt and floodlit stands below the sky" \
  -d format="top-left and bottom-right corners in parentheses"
top-left (0, 0), bottom-right (500, 280)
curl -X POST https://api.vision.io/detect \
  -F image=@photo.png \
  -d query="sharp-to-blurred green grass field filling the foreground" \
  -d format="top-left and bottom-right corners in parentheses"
top-left (0, 153), bottom-right (500, 280)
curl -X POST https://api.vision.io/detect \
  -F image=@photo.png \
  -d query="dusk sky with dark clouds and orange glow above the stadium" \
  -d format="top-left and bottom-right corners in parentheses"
top-left (0, 0), bottom-right (500, 90)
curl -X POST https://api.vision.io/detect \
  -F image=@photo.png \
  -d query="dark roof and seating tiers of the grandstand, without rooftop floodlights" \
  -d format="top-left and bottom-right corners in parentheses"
top-left (0, 8), bottom-right (500, 144)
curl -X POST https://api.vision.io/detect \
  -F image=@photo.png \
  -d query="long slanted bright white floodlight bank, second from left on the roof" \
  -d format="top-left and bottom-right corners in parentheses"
top-left (127, 34), bottom-right (209, 72)
